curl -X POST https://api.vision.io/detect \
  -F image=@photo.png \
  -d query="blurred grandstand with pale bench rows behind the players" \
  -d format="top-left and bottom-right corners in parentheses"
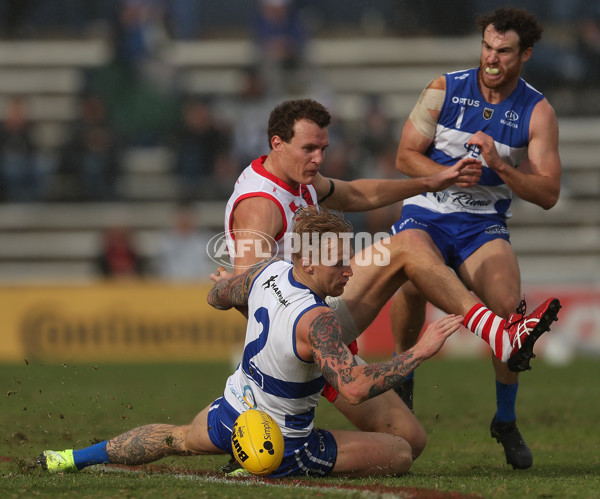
top-left (0, 0), bottom-right (600, 284)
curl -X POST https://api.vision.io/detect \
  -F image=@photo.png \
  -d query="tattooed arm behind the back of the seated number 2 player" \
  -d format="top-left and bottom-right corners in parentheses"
top-left (207, 261), bottom-right (268, 310)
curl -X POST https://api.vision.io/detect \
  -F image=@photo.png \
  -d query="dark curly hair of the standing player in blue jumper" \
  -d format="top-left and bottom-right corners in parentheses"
top-left (477, 7), bottom-right (544, 52)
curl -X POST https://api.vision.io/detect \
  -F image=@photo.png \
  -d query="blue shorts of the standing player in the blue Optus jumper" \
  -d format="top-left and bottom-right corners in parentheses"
top-left (391, 205), bottom-right (510, 272)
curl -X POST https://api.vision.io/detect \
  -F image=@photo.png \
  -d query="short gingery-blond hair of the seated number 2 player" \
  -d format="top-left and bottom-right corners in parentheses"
top-left (292, 206), bottom-right (354, 261)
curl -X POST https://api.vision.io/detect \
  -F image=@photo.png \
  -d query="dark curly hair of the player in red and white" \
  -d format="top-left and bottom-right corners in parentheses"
top-left (267, 99), bottom-right (331, 148)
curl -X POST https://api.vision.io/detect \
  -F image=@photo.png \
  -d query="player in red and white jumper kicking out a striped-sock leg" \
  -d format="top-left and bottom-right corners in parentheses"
top-left (225, 95), bottom-right (557, 470)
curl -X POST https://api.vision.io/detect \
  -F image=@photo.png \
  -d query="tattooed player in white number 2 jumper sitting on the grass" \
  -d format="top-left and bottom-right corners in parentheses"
top-left (38, 206), bottom-right (463, 476)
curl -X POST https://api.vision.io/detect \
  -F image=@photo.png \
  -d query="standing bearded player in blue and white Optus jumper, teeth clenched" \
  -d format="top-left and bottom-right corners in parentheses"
top-left (392, 8), bottom-right (561, 468)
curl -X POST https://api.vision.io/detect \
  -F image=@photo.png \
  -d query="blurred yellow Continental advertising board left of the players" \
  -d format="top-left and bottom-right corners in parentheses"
top-left (0, 283), bottom-right (246, 363)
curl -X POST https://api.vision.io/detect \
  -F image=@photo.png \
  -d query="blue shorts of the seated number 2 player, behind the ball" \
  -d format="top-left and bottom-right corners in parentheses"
top-left (208, 397), bottom-right (337, 477)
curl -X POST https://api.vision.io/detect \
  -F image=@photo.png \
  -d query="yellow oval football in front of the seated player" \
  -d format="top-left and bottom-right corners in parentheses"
top-left (231, 409), bottom-right (285, 476)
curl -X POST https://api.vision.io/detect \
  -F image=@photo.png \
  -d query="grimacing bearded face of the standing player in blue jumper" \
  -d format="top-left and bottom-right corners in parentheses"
top-left (479, 24), bottom-right (532, 90)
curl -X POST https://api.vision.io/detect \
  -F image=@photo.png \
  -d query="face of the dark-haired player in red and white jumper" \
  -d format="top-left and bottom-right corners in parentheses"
top-left (277, 120), bottom-right (329, 185)
